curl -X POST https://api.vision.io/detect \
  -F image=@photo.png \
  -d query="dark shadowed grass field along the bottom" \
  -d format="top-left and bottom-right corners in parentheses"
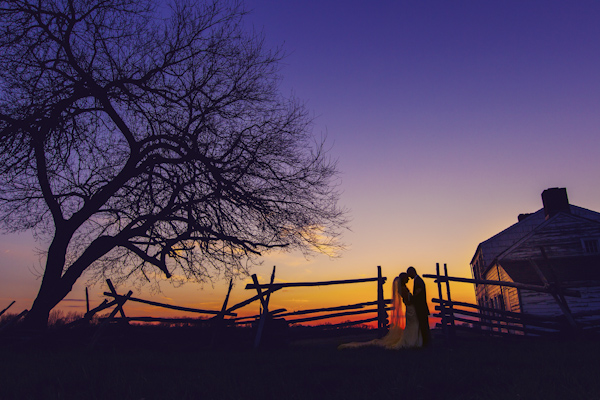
top-left (0, 332), bottom-right (600, 400)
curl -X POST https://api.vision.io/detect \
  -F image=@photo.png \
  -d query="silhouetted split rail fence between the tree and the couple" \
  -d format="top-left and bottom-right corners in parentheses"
top-left (63, 266), bottom-right (391, 347)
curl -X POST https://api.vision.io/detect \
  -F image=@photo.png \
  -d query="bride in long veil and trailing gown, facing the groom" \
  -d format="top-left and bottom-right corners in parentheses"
top-left (338, 272), bottom-right (423, 350)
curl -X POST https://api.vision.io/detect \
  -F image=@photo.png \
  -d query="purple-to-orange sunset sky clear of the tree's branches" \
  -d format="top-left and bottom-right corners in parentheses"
top-left (0, 0), bottom-right (600, 322)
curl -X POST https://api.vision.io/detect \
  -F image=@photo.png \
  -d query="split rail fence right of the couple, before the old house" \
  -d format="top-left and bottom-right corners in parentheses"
top-left (423, 264), bottom-right (600, 338)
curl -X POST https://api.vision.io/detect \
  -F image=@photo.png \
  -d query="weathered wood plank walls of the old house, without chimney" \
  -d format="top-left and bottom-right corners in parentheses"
top-left (471, 209), bottom-right (600, 327)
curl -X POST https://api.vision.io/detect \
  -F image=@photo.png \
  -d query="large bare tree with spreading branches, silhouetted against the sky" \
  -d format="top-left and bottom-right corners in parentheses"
top-left (0, 0), bottom-right (345, 327)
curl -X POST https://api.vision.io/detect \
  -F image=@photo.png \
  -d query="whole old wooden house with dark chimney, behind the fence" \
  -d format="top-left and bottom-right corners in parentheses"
top-left (471, 188), bottom-right (600, 327)
